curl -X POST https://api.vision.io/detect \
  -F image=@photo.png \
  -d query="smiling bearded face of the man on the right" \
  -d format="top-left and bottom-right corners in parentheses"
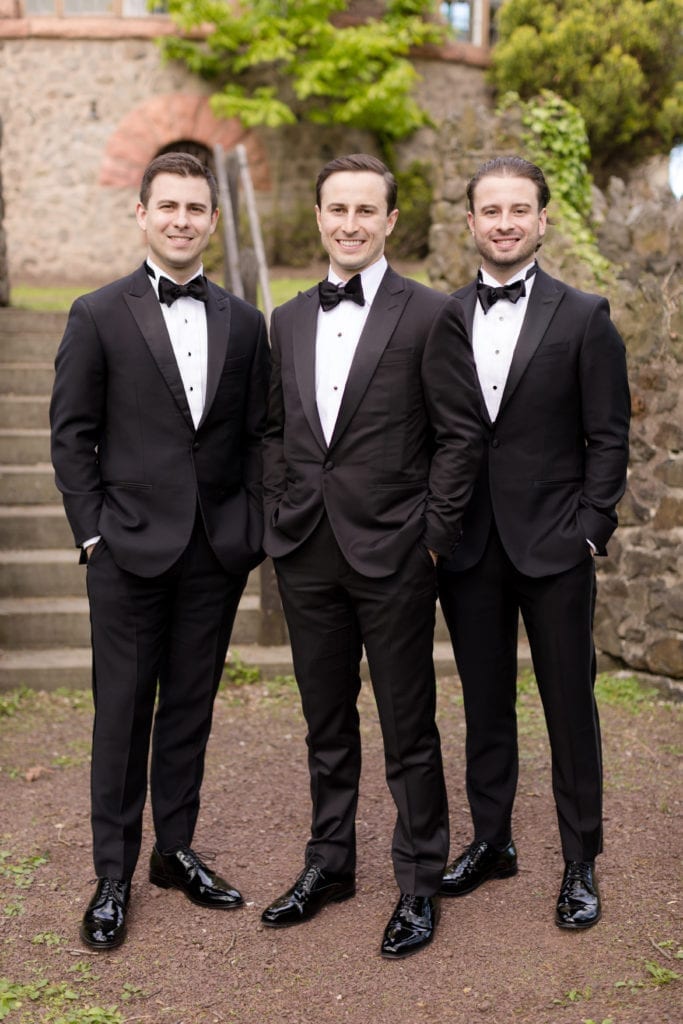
top-left (467, 174), bottom-right (547, 285)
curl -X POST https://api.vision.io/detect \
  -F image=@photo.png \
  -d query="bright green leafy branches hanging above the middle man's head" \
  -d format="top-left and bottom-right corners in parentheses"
top-left (161, 0), bottom-right (443, 144)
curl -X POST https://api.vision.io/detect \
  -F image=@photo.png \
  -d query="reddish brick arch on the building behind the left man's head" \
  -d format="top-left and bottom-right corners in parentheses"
top-left (99, 92), bottom-right (270, 189)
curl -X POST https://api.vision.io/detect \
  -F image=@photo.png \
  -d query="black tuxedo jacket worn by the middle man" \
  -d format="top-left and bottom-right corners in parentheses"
top-left (263, 267), bottom-right (482, 578)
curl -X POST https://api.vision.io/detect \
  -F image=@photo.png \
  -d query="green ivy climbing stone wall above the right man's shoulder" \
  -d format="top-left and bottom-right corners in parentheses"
top-left (499, 89), bottom-right (610, 283)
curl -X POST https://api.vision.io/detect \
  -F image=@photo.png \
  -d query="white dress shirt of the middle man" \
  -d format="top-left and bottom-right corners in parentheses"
top-left (315, 256), bottom-right (387, 444)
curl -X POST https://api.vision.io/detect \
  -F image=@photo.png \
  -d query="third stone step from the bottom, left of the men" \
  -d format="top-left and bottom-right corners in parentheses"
top-left (0, 548), bottom-right (85, 598)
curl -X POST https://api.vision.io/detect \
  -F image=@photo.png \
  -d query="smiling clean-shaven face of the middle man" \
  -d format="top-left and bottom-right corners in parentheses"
top-left (315, 171), bottom-right (398, 281)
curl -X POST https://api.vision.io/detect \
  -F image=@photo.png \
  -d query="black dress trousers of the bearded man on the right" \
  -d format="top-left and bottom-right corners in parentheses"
top-left (438, 526), bottom-right (602, 860)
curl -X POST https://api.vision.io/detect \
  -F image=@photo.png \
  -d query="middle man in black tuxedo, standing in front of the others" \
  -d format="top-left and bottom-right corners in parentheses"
top-left (262, 154), bottom-right (482, 957)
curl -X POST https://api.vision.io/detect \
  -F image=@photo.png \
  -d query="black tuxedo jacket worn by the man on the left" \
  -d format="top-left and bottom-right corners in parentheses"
top-left (50, 267), bottom-right (269, 577)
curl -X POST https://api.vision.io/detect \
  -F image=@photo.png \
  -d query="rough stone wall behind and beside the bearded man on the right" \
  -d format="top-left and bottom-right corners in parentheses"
top-left (429, 106), bottom-right (683, 680)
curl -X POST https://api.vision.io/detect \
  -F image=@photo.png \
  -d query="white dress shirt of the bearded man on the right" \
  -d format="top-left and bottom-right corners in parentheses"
top-left (472, 260), bottom-right (536, 421)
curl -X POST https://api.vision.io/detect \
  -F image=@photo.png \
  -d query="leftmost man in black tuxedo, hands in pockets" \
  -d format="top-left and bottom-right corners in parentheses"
top-left (50, 154), bottom-right (269, 949)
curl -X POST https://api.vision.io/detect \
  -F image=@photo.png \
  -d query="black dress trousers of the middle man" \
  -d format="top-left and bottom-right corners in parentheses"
top-left (275, 518), bottom-right (449, 896)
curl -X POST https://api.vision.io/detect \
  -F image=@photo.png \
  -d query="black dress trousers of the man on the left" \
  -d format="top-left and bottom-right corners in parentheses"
top-left (87, 515), bottom-right (247, 879)
